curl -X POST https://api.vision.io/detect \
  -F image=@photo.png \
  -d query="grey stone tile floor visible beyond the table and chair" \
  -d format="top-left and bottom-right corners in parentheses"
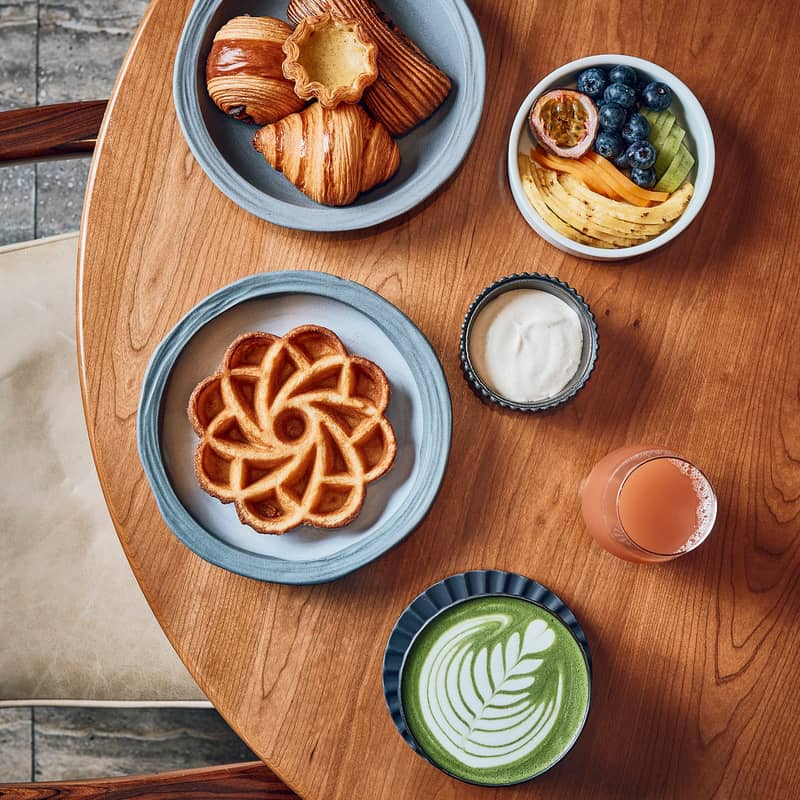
top-left (0, 0), bottom-right (255, 782)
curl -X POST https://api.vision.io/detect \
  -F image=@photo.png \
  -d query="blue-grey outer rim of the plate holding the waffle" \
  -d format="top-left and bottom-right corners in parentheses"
top-left (136, 270), bottom-right (452, 585)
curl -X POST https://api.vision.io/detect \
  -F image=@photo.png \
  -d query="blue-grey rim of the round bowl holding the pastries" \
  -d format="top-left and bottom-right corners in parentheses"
top-left (172, 0), bottom-right (486, 231)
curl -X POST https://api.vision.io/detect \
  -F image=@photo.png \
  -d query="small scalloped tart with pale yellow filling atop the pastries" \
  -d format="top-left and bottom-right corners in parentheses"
top-left (283, 11), bottom-right (378, 108)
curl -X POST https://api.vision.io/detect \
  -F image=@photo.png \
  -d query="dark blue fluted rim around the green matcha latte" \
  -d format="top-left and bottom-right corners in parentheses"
top-left (383, 569), bottom-right (592, 788)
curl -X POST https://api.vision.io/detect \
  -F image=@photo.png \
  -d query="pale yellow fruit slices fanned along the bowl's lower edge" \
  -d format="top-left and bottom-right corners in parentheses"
top-left (519, 154), bottom-right (693, 248)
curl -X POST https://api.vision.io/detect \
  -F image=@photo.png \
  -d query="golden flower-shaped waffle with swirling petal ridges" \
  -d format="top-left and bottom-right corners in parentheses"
top-left (188, 325), bottom-right (397, 533)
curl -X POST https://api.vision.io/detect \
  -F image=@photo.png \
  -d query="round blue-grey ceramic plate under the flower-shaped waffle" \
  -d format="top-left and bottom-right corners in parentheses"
top-left (137, 271), bottom-right (451, 584)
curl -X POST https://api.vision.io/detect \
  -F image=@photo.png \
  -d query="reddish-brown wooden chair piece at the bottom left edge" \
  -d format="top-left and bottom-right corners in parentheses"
top-left (0, 761), bottom-right (297, 800)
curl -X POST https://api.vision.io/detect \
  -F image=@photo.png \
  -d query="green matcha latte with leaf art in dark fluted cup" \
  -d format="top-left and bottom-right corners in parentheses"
top-left (383, 570), bottom-right (591, 786)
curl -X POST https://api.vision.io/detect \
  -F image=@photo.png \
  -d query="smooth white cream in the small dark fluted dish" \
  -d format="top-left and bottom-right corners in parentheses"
top-left (468, 289), bottom-right (583, 403)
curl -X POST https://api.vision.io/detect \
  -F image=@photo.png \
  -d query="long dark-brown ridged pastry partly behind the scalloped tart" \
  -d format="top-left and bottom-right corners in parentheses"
top-left (287, 0), bottom-right (450, 136)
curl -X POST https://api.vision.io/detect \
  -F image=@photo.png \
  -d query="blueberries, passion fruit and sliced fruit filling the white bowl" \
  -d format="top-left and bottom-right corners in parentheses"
top-left (519, 65), bottom-right (695, 248)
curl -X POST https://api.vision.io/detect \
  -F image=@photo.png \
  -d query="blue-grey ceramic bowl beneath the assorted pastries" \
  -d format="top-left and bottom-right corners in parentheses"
top-left (173, 0), bottom-right (486, 231)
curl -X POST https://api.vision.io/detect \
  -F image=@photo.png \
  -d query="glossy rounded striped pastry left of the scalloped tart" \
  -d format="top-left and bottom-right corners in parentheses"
top-left (206, 15), bottom-right (305, 125)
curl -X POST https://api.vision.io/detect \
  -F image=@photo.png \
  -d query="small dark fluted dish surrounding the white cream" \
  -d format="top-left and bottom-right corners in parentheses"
top-left (459, 272), bottom-right (598, 412)
